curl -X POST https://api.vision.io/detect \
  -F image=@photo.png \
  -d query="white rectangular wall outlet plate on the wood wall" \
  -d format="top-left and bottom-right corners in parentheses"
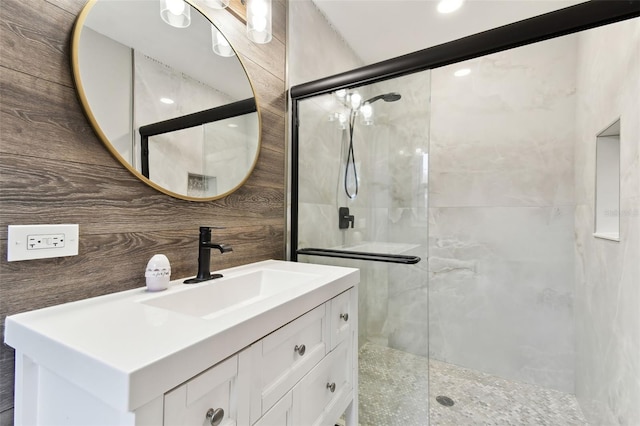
top-left (7, 224), bottom-right (79, 262)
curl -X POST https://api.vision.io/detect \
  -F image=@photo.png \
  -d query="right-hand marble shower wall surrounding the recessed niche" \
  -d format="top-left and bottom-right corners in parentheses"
top-left (575, 18), bottom-right (640, 425)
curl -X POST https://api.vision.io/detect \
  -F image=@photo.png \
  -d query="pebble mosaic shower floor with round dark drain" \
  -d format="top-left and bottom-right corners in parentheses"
top-left (359, 343), bottom-right (588, 426)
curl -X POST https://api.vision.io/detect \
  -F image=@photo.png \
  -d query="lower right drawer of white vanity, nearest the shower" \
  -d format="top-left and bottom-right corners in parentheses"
top-left (292, 341), bottom-right (353, 426)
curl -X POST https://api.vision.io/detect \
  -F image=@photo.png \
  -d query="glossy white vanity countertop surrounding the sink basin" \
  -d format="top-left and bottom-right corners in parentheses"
top-left (5, 260), bottom-right (360, 411)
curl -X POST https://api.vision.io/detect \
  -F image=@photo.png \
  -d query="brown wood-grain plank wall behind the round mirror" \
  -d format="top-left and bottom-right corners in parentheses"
top-left (0, 0), bottom-right (286, 426)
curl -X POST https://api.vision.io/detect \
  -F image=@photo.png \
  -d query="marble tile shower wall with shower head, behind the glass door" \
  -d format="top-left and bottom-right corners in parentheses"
top-left (299, 72), bottom-right (430, 355)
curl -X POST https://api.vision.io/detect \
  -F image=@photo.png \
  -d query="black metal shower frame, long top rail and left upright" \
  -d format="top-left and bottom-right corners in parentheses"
top-left (289, 0), bottom-right (640, 262)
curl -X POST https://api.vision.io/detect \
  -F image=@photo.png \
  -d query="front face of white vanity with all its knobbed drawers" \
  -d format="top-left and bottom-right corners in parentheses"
top-left (164, 289), bottom-right (357, 426)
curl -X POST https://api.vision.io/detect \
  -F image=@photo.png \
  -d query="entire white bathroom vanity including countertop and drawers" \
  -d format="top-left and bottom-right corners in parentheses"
top-left (5, 261), bottom-right (359, 426)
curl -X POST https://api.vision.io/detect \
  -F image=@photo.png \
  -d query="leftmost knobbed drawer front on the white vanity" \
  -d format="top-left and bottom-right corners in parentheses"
top-left (163, 355), bottom-right (238, 426)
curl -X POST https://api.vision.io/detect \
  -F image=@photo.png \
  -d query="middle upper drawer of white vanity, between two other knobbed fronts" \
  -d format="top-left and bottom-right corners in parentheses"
top-left (251, 304), bottom-right (328, 421)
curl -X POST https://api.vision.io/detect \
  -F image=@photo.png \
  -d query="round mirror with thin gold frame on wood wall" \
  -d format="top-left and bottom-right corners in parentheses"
top-left (72, 0), bottom-right (260, 201)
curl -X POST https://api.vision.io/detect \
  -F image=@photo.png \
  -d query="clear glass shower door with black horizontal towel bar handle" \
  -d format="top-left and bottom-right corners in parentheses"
top-left (297, 71), bottom-right (430, 425)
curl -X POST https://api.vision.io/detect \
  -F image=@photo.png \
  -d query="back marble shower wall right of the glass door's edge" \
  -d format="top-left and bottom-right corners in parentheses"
top-left (429, 36), bottom-right (577, 392)
